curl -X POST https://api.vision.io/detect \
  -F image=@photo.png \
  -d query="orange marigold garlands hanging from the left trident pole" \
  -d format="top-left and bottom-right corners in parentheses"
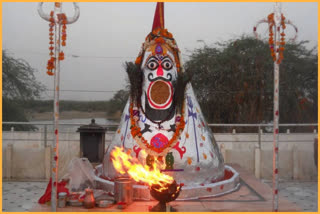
top-left (47, 11), bottom-right (67, 76)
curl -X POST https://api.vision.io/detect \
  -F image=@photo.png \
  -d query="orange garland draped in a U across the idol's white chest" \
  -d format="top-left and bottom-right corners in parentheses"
top-left (130, 102), bottom-right (185, 156)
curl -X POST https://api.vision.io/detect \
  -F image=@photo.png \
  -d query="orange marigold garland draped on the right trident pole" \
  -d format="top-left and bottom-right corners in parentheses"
top-left (268, 13), bottom-right (286, 64)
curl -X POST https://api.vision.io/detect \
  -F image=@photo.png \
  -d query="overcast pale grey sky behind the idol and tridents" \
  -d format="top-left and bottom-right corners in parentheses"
top-left (2, 2), bottom-right (318, 101)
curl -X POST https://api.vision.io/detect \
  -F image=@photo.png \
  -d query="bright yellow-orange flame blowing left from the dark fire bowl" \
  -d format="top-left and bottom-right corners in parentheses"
top-left (111, 147), bottom-right (174, 192)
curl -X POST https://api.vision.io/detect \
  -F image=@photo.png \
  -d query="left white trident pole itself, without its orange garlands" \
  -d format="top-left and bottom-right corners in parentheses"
top-left (38, 2), bottom-right (80, 212)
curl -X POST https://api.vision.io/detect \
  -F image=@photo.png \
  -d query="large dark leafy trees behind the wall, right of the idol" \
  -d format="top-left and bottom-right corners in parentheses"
top-left (185, 36), bottom-right (318, 131)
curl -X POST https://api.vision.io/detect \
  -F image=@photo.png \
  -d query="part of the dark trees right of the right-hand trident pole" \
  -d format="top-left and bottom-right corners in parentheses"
top-left (280, 41), bottom-right (318, 130)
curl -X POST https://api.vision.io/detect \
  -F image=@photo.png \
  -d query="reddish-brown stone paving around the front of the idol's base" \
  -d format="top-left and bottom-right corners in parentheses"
top-left (30, 165), bottom-right (302, 212)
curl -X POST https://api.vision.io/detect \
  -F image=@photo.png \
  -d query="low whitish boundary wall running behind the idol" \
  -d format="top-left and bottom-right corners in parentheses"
top-left (2, 130), bottom-right (318, 180)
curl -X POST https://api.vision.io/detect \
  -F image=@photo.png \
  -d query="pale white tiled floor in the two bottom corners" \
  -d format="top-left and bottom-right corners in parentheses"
top-left (2, 180), bottom-right (318, 212)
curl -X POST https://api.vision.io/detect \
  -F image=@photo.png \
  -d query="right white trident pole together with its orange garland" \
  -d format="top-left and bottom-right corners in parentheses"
top-left (253, 2), bottom-right (298, 212)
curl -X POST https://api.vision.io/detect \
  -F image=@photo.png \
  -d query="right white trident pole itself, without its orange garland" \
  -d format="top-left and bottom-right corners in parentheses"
top-left (253, 2), bottom-right (298, 212)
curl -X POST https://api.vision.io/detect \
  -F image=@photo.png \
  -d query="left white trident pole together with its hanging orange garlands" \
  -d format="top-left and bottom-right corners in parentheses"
top-left (38, 2), bottom-right (80, 212)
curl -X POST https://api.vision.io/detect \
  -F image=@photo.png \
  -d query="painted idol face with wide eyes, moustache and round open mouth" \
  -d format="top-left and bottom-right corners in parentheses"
top-left (141, 43), bottom-right (177, 121)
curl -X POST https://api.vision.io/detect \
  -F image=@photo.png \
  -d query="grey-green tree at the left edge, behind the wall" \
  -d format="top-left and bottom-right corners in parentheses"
top-left (2, 50), bottom-right (45, 130)
